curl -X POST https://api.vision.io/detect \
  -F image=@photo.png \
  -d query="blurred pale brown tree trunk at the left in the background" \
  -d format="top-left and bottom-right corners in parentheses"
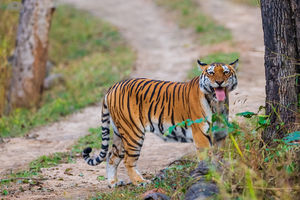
top-left (8, 0), bottom-right (54, 108)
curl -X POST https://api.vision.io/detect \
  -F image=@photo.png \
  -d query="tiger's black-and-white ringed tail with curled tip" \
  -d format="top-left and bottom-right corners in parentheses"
top-left (82, 98), bottom-right (110, 166)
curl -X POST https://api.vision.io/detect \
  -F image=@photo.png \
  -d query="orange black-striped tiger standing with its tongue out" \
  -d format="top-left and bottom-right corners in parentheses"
top-left (82, 59), bottom-right (238, 187)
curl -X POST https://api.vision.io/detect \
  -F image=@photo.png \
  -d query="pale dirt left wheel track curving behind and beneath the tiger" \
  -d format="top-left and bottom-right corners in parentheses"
top-left (0, 0), bottom-right (198, 199)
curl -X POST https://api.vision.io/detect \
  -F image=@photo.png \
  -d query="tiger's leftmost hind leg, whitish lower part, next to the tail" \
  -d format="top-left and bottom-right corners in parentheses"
top-left (106, 130), bottom-right (124, 188)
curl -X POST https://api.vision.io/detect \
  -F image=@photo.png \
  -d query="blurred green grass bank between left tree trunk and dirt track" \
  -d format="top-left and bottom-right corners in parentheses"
top-left (0, 6), bottom-right (135, 137)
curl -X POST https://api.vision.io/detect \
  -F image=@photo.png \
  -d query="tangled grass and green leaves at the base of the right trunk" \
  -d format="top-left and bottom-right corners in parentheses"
top-left (212, 112), bottom-right (300, 199)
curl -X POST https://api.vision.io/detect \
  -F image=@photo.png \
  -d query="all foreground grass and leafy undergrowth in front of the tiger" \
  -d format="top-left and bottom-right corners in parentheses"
top-left (92, 112), bottom-right (300, 200)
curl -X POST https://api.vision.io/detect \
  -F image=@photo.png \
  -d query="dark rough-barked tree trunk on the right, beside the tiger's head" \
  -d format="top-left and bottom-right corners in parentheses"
top-left (261, 0), bottom-right (300, 143)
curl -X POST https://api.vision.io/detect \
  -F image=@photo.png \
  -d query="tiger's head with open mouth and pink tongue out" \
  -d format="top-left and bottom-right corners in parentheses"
top-left (198, 59), bottom-right (238, 101)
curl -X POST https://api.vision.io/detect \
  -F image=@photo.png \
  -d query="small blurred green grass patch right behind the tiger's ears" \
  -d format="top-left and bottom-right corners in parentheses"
top-left (188, 52), bottom-right (239, 79)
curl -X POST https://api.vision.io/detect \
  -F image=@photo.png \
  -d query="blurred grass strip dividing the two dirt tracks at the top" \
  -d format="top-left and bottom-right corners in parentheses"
top-left (156, 0), bottom-right (232, 45)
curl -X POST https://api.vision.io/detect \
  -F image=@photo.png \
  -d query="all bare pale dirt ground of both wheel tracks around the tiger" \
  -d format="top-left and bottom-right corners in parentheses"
top-left (0, 0), bottom-right (265, 199)
